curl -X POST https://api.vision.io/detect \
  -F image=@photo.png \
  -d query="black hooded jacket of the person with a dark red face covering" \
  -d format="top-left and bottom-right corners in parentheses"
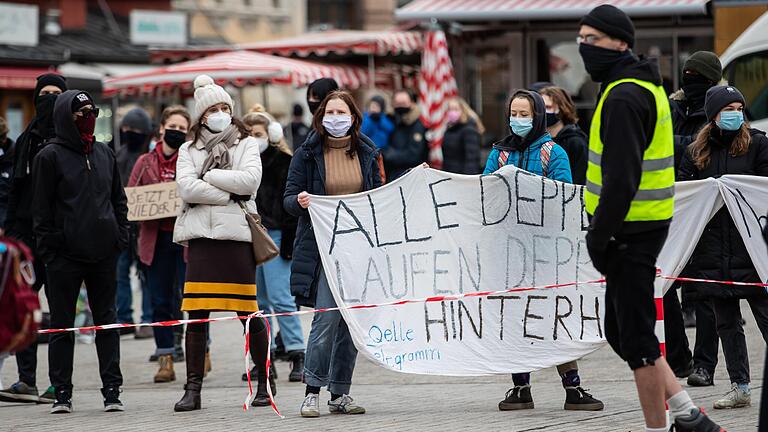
top-left (33, 90), bottom-right (128, 264)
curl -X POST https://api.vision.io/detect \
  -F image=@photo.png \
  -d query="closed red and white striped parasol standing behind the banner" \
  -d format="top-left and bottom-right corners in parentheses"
top-left (419, 30), bottom-right (458, 168)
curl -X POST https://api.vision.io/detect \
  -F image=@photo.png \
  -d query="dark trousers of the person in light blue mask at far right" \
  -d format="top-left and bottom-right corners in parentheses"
top-left (712, 297), bottom-right (768, 384)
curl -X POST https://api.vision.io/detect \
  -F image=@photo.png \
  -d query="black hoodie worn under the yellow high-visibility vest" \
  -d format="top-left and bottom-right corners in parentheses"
top-left (590, 56), bottom-right (670, 247)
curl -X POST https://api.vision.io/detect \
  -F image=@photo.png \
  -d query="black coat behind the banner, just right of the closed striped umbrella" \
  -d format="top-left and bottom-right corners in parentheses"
top-left (438, 120), bottom-right (480, 174)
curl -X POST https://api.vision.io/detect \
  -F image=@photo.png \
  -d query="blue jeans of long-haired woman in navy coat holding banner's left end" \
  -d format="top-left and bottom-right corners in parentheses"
top-left (304, 268), bottom-right (357, 394)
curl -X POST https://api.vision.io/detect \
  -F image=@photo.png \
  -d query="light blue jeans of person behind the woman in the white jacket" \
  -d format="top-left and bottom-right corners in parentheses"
top-left (256, 230), bottom-right (304, 352)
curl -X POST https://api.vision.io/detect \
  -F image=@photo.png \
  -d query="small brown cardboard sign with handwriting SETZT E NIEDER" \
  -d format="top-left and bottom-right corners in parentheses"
top-left (125, 182), bottom-right (183, 221)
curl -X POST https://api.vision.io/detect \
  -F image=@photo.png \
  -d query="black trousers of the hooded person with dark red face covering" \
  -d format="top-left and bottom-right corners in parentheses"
top-left (46, 256), bottom-right (123, 391)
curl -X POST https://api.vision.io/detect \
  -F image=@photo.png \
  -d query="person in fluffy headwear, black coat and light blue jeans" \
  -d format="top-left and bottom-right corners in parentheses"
top-left (243, 105), bottom-right (304, 382)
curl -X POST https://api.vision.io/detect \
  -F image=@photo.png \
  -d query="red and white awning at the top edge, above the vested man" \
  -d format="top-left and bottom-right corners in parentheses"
top-left (395, 0), bottom-right (709, 21)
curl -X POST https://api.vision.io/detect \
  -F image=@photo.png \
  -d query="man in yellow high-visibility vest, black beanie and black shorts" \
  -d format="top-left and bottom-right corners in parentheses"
top-left (578, 5), bottom-right (719, 432)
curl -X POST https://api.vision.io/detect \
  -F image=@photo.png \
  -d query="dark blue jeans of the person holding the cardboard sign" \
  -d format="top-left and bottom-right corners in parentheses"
top-left (147, 231), bottom-right (187, 355)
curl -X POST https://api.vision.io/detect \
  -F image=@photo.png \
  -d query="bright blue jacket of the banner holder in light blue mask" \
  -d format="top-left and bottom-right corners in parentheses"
top-left (483, 132), bottom-right (573, 183)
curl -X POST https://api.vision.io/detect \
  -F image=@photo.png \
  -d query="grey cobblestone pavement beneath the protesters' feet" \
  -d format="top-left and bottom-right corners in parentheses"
top-left (0, 308), bottom-right (765, 432)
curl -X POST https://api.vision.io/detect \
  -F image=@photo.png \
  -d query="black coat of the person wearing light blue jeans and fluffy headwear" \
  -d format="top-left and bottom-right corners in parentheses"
top-left (256, 146), bottom-right (297, 259)
